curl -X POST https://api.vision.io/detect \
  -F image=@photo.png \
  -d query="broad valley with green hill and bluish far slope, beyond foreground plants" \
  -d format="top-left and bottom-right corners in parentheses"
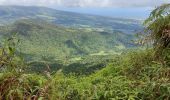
top-left (0, 6), bottom-right (142, 74)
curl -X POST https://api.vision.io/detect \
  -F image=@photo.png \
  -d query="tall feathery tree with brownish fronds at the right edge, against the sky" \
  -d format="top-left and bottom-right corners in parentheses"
top-left (144, 4), bottom-right (170, 61)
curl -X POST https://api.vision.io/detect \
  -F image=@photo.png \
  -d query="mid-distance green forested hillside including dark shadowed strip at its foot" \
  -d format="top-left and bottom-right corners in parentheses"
top-left (0, 20), bottom-right (135, 75)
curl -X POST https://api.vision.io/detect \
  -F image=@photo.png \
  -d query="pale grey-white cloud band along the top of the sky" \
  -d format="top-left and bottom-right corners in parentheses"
top-left (0, 0), bottom-right (170, 7)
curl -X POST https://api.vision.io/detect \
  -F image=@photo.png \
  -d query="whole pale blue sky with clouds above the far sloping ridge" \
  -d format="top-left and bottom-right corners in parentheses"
top-left (0, 0), bottom-right (170, 19)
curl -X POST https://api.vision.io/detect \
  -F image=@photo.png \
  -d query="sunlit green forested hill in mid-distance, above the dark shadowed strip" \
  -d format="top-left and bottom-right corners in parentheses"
top-left (0, 20), bottom-right (134, 59)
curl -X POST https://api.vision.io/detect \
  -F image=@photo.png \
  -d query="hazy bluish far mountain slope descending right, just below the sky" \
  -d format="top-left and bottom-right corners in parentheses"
top-left (0, 6), bottom-right (142, 33)
